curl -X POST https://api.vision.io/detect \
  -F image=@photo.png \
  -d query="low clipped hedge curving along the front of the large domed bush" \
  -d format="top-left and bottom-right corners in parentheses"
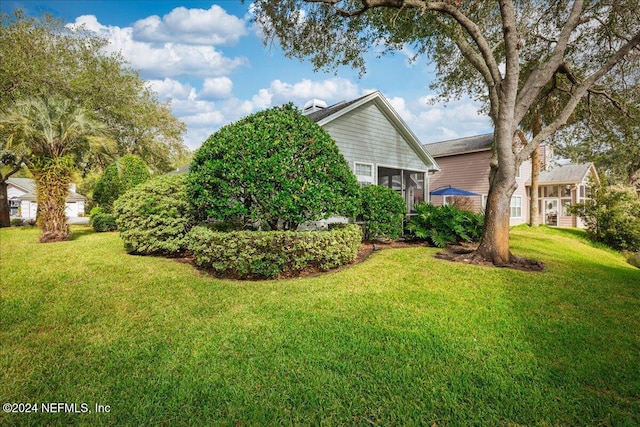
top-left (189, 225), bottom-right (362, 278)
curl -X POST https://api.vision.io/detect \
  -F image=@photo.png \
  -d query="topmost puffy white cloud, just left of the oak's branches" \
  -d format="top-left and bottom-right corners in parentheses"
top-left (133, 4), bottom-right (247, 45)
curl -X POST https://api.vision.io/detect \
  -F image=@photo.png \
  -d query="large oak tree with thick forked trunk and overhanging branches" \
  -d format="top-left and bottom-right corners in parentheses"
top-left (254, 0), bottom-right (640, 265)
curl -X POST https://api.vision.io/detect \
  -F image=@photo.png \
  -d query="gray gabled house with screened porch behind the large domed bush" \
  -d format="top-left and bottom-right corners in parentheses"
top-left (303, 91), bottom-right (440, 213)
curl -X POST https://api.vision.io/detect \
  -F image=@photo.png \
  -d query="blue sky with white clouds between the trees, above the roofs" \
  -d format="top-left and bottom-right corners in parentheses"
top-left (1, 0), bottom-right (491, 149)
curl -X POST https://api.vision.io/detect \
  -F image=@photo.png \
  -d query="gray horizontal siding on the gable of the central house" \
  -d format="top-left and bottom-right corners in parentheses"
top-left (323, 103), bottom-right (427, 171)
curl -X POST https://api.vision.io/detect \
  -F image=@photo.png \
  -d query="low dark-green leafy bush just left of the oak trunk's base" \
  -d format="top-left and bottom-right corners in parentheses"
top-left (408, 203), bottom-right (484, 248)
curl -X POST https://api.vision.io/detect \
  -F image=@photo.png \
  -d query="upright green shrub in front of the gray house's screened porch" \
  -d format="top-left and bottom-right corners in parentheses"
top-left (360, 185), bottom-right (407, 240)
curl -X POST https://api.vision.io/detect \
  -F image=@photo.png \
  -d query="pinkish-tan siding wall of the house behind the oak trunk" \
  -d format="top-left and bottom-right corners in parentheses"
top-left (426, 152), bottom-right (531, 226)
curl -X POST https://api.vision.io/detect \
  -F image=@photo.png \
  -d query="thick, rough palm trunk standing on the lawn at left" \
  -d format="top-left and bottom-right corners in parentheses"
top-left (32, 163), bottom-right (71, 243)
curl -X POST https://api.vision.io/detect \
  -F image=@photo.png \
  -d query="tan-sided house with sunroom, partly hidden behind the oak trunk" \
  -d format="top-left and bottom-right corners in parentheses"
top-left (425, 134), bottom-right (598, 227)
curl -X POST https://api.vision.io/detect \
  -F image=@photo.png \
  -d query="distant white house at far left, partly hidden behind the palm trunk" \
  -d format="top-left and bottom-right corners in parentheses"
top-left (7, 178), bottom-right (87, 219)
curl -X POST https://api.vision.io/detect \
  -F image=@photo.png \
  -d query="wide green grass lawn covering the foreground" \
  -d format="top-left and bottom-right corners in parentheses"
top-left (0, 226), bottom-right (640, 426)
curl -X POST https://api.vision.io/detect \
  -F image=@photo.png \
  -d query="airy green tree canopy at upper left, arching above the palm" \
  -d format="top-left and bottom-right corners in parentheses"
top-left (0, 11), bottom-right (188, 171)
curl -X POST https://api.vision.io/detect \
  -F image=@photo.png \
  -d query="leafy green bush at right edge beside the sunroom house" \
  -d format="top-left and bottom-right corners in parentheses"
top-left (570, 186), bottom-right (640, 251)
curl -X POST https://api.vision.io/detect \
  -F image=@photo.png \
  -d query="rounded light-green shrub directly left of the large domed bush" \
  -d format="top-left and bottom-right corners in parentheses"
top-left (114, 175), bottom-right (192, 255)
